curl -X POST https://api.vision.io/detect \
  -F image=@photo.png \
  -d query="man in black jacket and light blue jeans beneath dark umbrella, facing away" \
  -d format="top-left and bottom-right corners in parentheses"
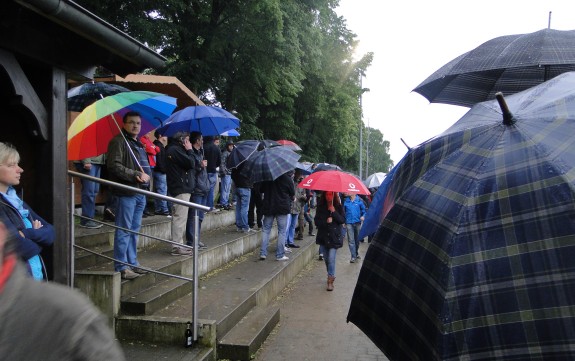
top-left (260, 172), bottom-right (295, 261)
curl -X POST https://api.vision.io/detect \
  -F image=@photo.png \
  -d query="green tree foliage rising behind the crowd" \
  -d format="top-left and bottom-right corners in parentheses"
top-left (77, 0), bottom-right (391, 173)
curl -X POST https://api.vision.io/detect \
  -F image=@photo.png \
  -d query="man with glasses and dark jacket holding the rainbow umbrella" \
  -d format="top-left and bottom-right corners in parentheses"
top-left (106, 112), bottom-right (150, 280)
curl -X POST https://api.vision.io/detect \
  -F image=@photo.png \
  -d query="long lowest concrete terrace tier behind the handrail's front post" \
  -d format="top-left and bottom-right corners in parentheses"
top-left (116, 232), bottom-right (317, 348)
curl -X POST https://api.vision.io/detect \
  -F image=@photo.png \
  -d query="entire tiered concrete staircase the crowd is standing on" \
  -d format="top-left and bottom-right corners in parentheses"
top-left (75, 211), bottom-right (317, 360)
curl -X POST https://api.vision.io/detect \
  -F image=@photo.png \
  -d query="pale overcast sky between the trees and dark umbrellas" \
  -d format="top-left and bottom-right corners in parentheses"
top-left (336, 0), bottom-right (575, 163)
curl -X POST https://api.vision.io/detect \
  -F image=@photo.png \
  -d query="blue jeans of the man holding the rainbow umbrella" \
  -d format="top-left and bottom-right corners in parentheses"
top-left (114, 194), bottom-right (146, 272)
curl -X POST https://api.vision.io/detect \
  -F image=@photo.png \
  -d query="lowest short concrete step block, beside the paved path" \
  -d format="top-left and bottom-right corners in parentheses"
top-left (218, 306), bottom-right (280, 361)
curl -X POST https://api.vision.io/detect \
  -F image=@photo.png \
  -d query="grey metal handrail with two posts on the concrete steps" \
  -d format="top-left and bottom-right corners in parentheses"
top-left (68, 170), bottom-right (210, 343)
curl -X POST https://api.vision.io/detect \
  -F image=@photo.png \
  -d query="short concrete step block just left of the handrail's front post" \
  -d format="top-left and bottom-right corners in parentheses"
top-left (120, 278), bottom-right (193, 315)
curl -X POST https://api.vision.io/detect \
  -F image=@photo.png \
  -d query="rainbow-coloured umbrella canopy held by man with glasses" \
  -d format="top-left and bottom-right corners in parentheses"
top-left (68, 91), bottom-right (176, 160)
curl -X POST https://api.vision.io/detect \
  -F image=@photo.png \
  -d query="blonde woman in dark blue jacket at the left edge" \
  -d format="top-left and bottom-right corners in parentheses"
top-left (0, 143), bottom-right (55, 280)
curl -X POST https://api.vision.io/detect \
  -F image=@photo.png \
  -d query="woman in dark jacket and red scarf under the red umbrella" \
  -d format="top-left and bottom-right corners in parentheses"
top-left (314, 192), bottom-right (345, 291)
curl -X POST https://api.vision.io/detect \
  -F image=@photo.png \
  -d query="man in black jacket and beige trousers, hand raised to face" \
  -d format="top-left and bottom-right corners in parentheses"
top-left (166, 132), bottom-right (197, 256)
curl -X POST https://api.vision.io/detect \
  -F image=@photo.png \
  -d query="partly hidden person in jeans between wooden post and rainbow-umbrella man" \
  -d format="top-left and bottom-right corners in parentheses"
top-left (74, 154), bottom-right (104, 229)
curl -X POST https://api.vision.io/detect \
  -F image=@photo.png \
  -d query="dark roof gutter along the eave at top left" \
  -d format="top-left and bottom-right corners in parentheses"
top-left (14, 0), bottom-right (167, 69)
